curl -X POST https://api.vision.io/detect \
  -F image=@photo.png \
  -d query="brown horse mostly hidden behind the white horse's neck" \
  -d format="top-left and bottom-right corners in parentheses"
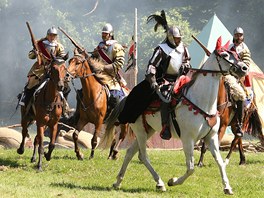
top-left (198, 76), bottom-right (264, 167)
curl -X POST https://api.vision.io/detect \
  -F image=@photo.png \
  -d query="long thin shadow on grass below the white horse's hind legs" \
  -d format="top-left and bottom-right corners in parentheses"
top-left (50, 182), bottom-right (153, 193)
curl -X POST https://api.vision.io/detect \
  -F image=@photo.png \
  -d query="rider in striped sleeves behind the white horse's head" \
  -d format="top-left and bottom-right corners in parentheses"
top-left (225, 27), bottom-right (252, 137)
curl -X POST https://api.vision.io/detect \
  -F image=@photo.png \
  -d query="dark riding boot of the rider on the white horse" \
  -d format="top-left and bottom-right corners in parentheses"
top-left (160, 102), bottom-right (171, 140)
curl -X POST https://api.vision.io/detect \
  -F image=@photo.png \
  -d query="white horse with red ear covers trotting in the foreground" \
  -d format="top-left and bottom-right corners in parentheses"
top-left (103, 37), bottom-right (243, 194)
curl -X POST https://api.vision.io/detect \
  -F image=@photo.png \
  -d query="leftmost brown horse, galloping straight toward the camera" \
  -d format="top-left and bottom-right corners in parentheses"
top-left (17, 56), bottom-right (66, 171)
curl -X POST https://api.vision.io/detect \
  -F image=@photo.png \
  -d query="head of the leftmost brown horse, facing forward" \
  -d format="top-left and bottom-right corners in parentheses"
top-left (49, 56), bottom-right (66, 91)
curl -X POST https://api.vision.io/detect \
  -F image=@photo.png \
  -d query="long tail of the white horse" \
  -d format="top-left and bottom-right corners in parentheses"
top-left (100, 97), bottom-right (126, 148)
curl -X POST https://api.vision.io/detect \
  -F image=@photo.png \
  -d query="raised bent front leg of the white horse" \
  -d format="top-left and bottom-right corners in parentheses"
top-left (168, 140), bottom-right (194, 186)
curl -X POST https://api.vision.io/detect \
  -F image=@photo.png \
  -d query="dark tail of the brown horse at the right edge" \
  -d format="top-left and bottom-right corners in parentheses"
top-left (246, 108), bottom-right (264, 142)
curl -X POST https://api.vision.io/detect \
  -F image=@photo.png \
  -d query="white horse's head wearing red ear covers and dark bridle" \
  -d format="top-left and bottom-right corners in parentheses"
top-left (214, 36), bottom-right (249, 78)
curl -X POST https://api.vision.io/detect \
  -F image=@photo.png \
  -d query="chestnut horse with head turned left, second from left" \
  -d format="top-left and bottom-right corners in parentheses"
top-left (65, 50), bottom-right (128, 160)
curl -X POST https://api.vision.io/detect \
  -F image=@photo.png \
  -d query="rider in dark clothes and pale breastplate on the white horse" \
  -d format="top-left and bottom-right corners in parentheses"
top-left (146, 26), bottom-right (190, 140)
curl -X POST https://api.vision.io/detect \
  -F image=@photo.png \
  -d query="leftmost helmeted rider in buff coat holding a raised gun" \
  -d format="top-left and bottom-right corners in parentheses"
top-left (19, 27), bottom-right (70, 117)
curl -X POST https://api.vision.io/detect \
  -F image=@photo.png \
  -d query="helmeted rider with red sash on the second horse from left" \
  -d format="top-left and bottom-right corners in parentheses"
top-left (92, 23), bottom-right (125, 108)
